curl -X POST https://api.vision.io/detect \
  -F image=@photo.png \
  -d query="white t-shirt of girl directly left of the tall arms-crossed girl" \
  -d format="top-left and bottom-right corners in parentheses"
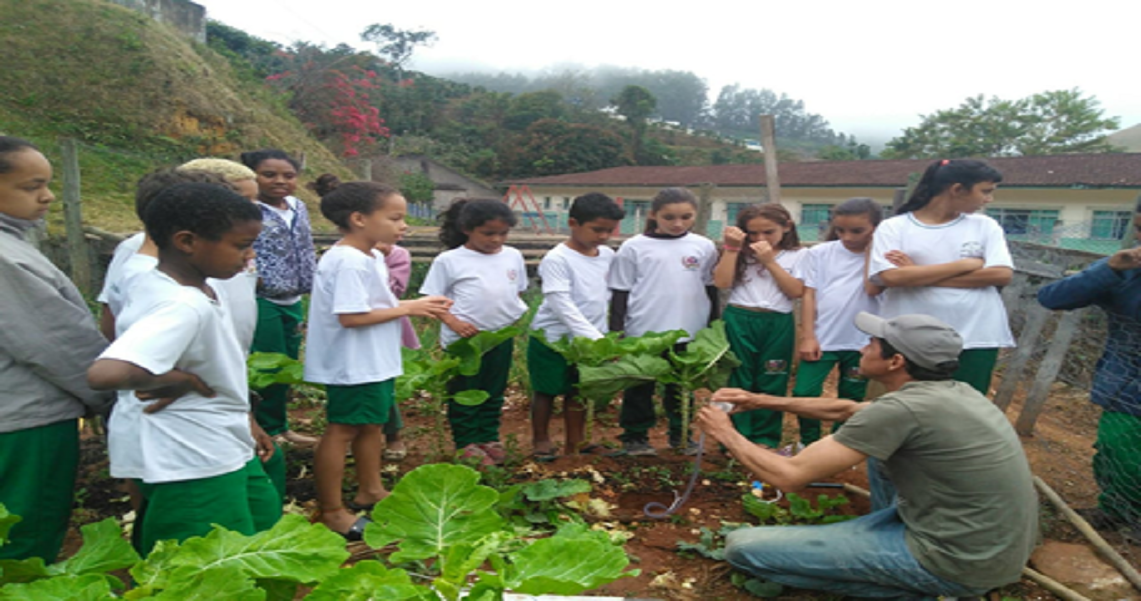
top-left (800, 239), bottom-right (880, 351)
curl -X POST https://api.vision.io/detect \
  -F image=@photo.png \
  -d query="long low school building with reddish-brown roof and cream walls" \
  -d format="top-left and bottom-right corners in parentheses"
top-left (504, 153), bottom-right (1141, 252)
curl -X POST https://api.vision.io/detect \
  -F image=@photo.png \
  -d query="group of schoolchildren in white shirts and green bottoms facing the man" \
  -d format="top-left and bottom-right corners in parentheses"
top-left (0, 132), bottom-right (1011, 561)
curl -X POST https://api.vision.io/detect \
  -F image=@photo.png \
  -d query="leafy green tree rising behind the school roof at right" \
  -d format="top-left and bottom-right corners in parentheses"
top-left (882, 88), bottom-right (1119, 159)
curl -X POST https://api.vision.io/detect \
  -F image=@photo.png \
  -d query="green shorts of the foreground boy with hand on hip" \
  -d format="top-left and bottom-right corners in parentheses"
top-left (132, 456), bottom-right (282, 555)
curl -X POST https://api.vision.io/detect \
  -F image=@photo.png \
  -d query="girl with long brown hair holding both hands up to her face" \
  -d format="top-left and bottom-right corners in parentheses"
top-left (713, 203), bottom-right (808, 448)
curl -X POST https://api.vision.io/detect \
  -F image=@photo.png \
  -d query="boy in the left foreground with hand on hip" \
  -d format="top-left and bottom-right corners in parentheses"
top-left (88, 184), bottom-right (281, 554)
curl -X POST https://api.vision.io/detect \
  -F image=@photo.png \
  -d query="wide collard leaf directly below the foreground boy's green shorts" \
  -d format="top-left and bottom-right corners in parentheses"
top-left (131, 514), bottom-right (349, 588)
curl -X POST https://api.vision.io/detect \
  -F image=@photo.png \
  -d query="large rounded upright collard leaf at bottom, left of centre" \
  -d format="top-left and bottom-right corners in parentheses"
top-left (365, 463), bottom-right (503, 563)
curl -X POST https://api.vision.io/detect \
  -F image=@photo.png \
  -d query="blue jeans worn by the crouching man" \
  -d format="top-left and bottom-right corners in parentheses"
top-left (725, 458), bottom-right (986, 599)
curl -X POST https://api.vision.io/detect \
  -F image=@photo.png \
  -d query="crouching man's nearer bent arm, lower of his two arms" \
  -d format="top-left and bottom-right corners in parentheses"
top-left (696, 407), bottom-right (867, 492)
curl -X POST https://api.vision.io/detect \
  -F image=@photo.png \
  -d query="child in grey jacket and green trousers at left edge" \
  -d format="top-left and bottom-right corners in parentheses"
top-left (0, 136), bottom-right (112, 563)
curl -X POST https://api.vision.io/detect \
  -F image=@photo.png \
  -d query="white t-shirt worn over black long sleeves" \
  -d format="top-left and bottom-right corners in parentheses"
top-left (608, 233), bottom-right (717, 342)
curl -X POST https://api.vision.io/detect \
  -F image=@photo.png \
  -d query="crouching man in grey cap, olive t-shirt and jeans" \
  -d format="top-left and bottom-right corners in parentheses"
top-left (697, 312), bottom-right (1038, 599)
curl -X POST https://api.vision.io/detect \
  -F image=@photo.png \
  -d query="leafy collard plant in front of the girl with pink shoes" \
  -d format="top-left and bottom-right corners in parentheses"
top-left (396, 326), bottom-right (524, 457)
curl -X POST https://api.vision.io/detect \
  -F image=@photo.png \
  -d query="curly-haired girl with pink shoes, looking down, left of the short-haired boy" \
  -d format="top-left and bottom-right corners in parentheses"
top-left (420, 198), bottom-right (527, 465)
